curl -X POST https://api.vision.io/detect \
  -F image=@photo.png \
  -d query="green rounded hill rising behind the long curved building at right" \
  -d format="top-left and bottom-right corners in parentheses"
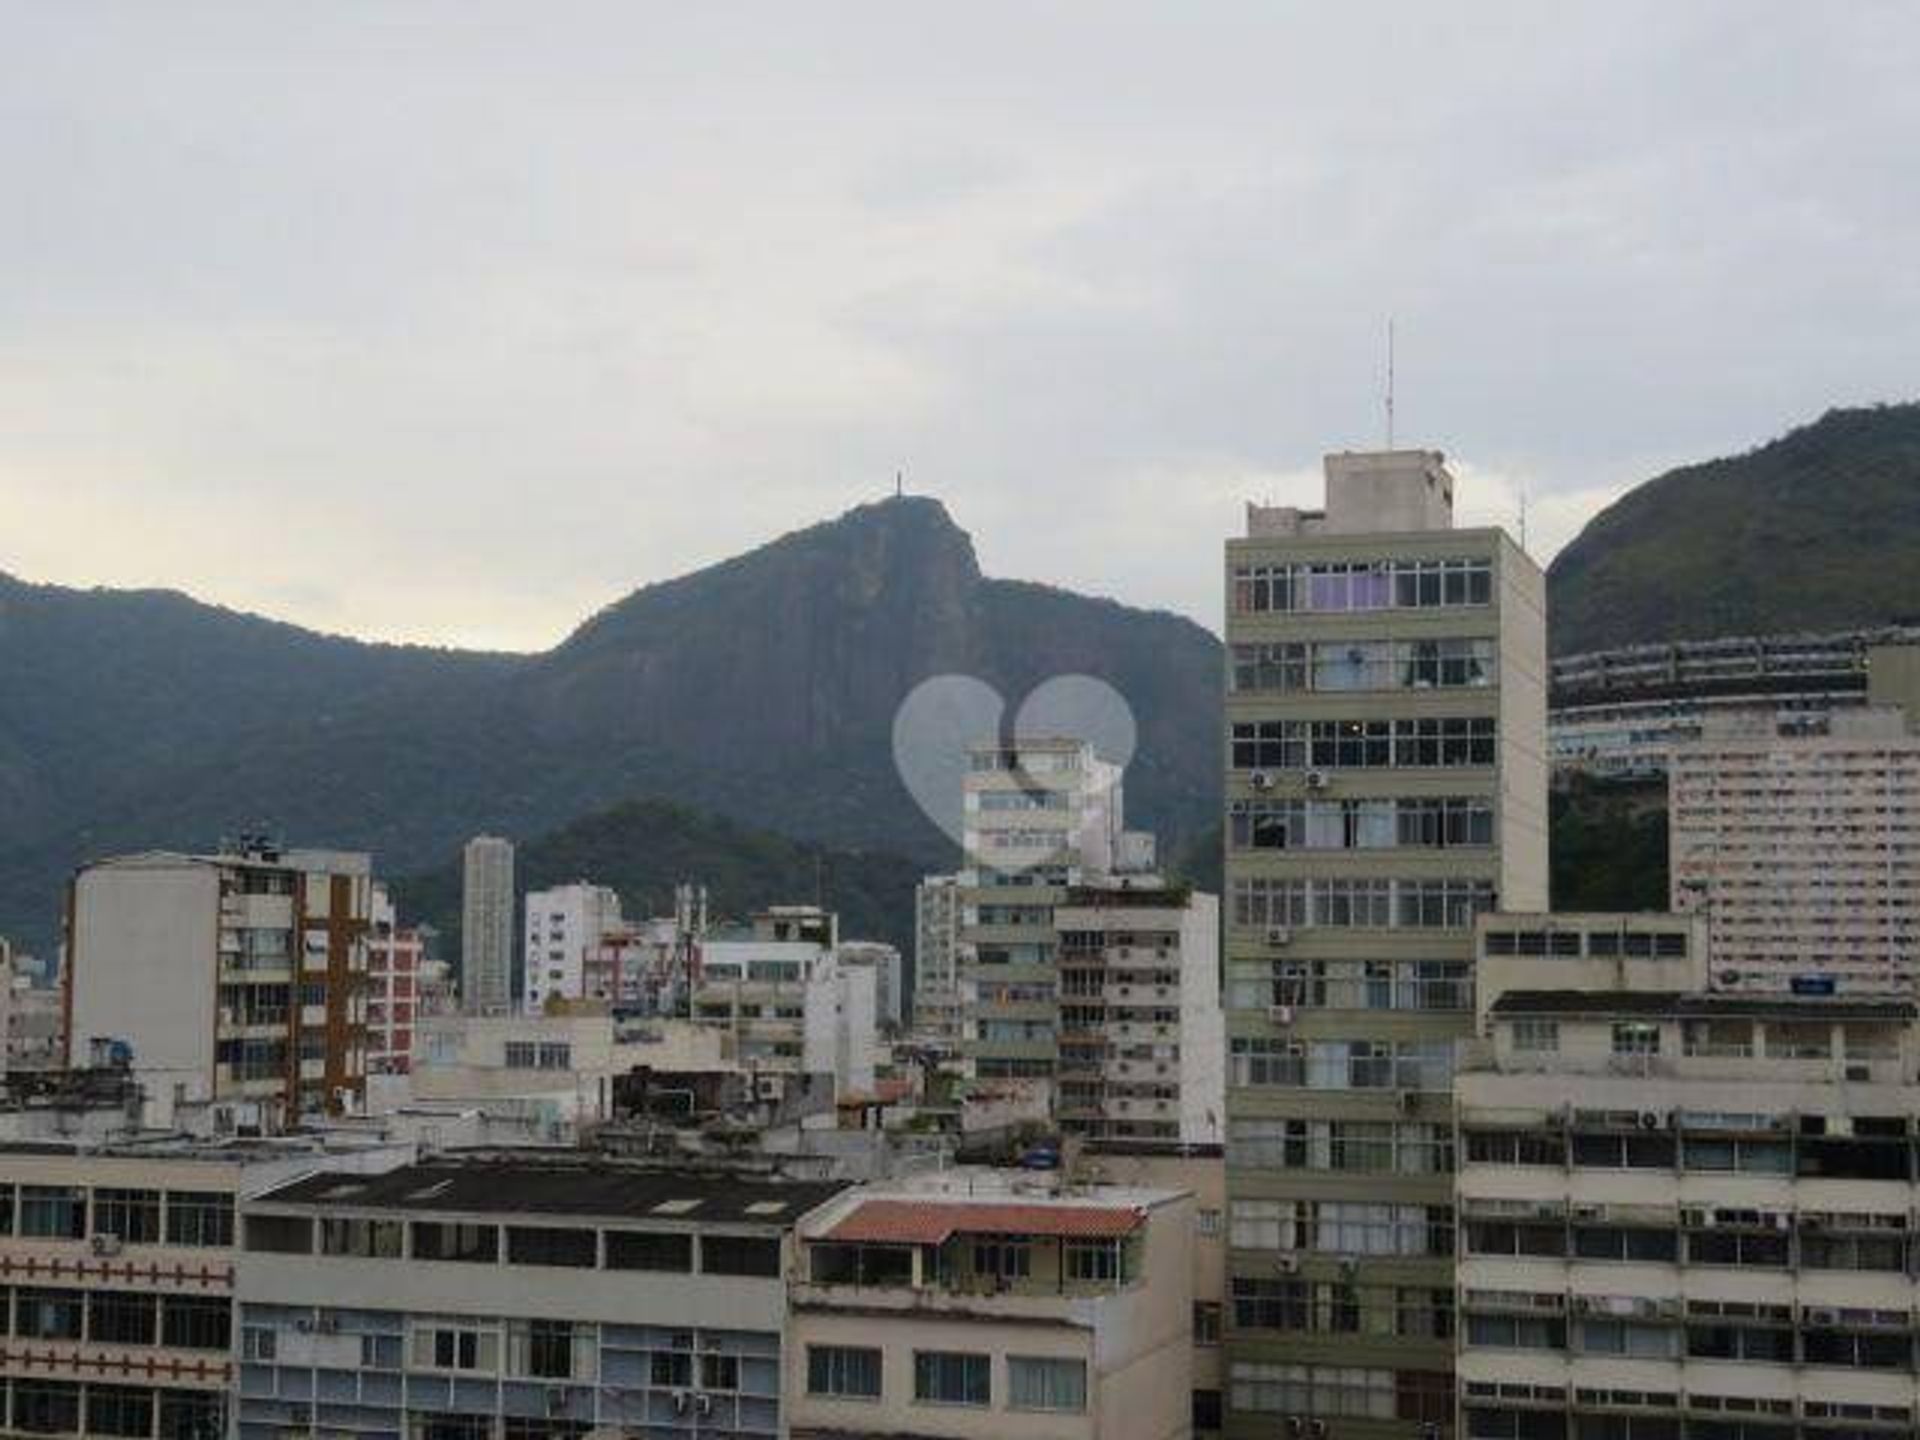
top-left (1548, 403), bottom-right (1920, 655)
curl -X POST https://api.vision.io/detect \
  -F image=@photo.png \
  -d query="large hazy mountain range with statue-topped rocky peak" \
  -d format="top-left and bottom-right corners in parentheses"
top-left (0, 497), bottom-right (1221, 950)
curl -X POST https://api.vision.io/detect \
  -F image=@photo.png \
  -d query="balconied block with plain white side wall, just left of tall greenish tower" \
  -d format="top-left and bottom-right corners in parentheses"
top-left (1059, 885), bottom-right (1227, 1144)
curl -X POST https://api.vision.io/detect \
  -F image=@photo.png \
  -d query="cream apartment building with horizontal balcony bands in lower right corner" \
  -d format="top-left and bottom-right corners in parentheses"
top-left (1455, 916), bottom-right (1920, 1440)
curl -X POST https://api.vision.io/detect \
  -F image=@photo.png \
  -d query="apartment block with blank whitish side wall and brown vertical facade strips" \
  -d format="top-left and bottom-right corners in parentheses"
top-left (63, 843), bottom-right (372, 1125)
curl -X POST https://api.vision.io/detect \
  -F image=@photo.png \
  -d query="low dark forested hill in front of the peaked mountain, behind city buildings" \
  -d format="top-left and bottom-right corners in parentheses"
top-left (394, 801), bottom-right (924, 966)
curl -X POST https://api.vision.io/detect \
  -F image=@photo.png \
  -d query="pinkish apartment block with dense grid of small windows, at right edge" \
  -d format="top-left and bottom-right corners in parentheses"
top-left (1668, 702), bottom-right (1920, 995)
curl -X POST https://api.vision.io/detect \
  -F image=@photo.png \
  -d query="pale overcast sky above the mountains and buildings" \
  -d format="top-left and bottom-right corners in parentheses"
top-left (0, 0), bottom-right (1920, 649)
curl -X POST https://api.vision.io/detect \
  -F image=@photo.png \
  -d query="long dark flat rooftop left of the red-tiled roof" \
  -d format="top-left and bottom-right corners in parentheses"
top-left (259, 1160), bottom-right (847, 1227)
